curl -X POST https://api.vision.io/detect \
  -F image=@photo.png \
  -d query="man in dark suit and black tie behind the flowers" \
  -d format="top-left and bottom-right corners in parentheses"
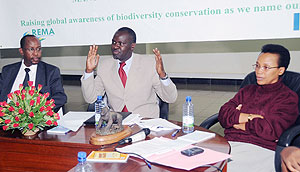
top-left (0, 35), bottom-right (67, 112)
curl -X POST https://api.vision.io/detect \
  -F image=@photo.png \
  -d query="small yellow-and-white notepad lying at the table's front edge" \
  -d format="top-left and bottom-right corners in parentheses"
top-left (86, 151), bottom-right (129, 163)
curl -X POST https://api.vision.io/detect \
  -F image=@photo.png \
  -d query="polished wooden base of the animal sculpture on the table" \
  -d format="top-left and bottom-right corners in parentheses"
top-left (90, 125), bottom-right (132, 145)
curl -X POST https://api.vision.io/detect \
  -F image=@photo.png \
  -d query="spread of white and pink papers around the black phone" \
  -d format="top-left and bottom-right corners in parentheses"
top-left (117, 131), bottom-right (231, 170)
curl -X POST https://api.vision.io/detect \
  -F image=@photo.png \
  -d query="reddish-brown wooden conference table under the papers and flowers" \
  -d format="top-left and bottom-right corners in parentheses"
top-left (0, 120), bottom-right (230, 172)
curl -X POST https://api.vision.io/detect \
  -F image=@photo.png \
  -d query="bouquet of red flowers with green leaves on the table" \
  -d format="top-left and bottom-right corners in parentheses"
top-left (0, 81), bottom-right (60, 134)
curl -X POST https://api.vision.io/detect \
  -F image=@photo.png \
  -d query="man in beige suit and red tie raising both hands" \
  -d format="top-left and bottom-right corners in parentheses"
top-left (81, 27), bottom-right (177, 118)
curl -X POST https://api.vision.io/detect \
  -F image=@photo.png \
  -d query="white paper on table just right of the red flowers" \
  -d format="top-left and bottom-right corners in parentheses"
top-left (58, 111), bottom-right (94, 131)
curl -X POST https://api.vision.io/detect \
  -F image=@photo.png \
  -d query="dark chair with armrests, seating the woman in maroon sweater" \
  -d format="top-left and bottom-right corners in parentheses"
top-left (200, 71), bottom-right (300, 172)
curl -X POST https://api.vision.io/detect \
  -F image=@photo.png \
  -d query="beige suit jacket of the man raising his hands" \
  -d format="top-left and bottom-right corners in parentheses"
top-left (81, 54), bottom-right (177, 118)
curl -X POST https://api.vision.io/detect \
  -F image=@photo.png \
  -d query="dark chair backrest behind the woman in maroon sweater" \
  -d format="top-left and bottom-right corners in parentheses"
top-left (240, 71), bottom-right (300, 124)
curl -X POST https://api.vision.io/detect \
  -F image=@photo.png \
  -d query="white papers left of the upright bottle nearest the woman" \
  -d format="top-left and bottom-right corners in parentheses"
top-left (136, 118), bottom-right (181, 131)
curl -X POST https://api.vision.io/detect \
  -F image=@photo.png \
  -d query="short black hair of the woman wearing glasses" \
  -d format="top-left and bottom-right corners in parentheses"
top-left (261, 44), bottom-right (291, 70)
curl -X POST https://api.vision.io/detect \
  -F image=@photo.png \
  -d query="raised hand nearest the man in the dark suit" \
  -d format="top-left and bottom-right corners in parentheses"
top-left (85, 45), bottom-right (100, 73)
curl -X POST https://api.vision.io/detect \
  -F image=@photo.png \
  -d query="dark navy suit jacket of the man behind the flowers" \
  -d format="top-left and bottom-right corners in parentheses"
top-left (0, 61), bottom-right (67, 112)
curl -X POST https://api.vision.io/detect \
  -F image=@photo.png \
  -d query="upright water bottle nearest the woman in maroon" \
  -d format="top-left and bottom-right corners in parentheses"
top-left (182, 96), bottom-right (194, 133)
